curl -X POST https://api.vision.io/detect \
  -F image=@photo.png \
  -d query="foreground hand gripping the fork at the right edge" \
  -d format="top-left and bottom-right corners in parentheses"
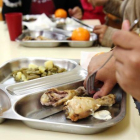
top-left (113, 21), bottom-right (140, 101)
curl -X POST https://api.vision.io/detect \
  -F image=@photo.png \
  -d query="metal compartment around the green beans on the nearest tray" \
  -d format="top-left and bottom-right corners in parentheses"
top-left (0, 57), bottom-right (78, 85)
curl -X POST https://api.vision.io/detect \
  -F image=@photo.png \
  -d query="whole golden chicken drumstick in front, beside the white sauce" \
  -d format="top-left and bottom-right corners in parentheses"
top-left (63, 94), bottom-right (115, 121)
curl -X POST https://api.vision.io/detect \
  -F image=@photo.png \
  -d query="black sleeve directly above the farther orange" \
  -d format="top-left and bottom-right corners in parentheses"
top-left (54, 0), bottom-right (83, 14)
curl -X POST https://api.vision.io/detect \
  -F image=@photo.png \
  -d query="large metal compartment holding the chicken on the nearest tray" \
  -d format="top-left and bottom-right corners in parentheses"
top-left (15, 81), bottom-right (126, 134)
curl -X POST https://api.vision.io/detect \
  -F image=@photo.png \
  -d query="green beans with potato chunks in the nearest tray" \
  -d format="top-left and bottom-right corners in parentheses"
top-left (12, 61), bottom-right (66, 81)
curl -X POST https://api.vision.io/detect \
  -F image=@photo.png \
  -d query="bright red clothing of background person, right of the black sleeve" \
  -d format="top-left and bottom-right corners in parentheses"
top-left (81, 0), bottom-right (105, 24)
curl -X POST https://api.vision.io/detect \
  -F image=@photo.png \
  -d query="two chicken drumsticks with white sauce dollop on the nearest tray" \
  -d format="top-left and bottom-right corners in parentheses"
top-left (40, 87), bottom-right (115, 121)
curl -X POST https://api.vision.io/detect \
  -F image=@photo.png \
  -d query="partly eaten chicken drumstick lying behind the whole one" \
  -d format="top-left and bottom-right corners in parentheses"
top-left (40, 87), bottom-right (85, 107)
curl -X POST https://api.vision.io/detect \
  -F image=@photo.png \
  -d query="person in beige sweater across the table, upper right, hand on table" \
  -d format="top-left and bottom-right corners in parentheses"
top-left (88, 0), bottom-right (140, 47)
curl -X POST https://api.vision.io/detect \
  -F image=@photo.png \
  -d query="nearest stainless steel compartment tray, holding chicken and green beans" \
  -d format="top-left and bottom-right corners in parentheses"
top-left (0, 58), bottom-right (126, 134)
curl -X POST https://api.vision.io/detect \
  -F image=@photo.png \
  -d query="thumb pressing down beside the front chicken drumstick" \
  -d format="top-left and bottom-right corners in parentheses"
top-left (93, 81), bottom-right (115, 99)
